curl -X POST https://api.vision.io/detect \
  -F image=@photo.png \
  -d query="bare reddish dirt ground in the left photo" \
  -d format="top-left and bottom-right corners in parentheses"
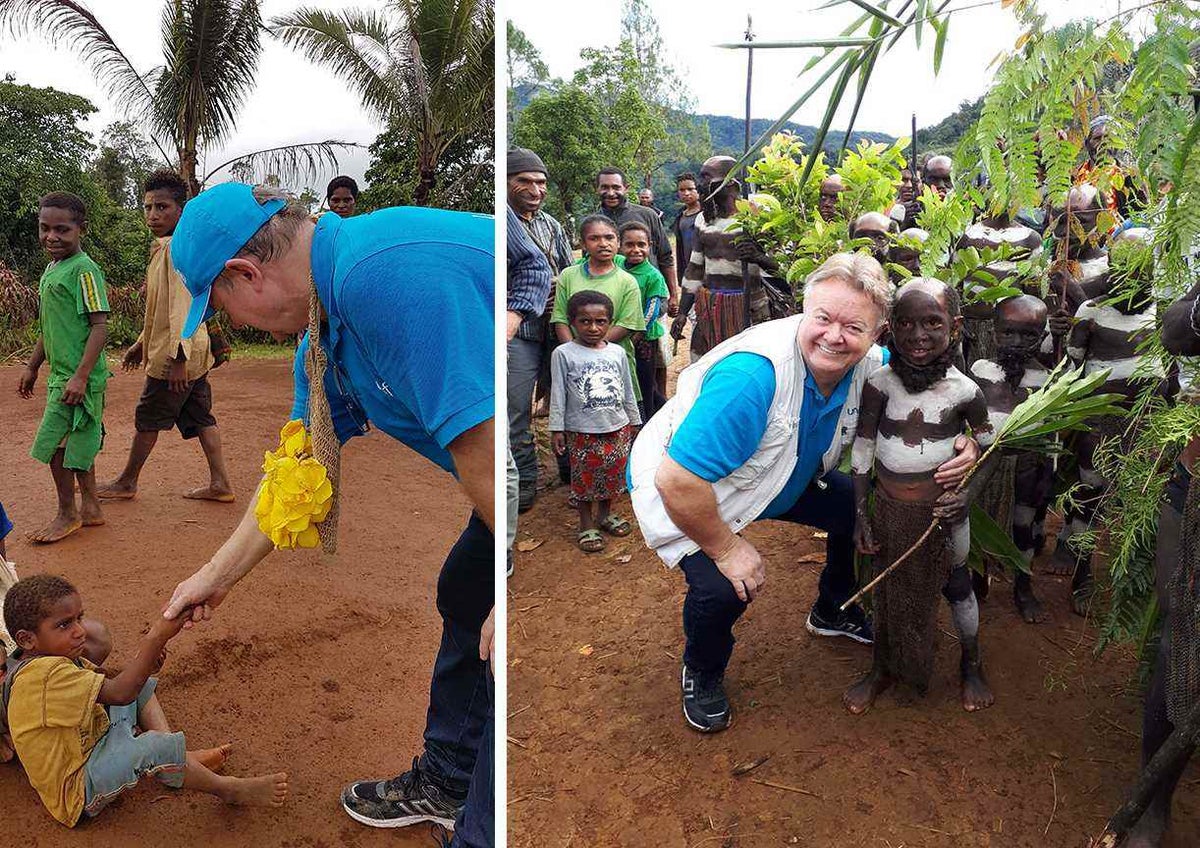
top-left (0, 359), bottom-right (468, 848)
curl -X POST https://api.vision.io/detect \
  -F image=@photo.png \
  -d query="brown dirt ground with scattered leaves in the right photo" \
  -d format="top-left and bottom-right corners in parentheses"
top-left (508, 343), bottom-right (1200, 848)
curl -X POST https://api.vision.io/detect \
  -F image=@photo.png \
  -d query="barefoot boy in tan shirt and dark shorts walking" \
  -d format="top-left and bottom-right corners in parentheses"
top-left (96, 170), bottom-right (234, 504)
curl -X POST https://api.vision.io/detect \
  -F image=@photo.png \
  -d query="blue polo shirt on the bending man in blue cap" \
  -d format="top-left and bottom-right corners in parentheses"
top-left (292, 208), bottom-right (496, 473)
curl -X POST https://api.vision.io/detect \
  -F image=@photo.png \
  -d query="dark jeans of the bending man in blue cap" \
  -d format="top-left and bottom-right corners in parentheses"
top-left (420, 513), bottom-right (496, 848)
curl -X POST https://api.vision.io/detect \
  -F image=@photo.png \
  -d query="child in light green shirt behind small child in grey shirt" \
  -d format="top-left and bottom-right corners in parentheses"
top-left (550, 215), bottom-right (646, 402)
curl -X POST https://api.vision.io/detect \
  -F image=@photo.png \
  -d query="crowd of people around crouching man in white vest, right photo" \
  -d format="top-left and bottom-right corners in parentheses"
top-left (509, 110), bottom-right (1200, 846)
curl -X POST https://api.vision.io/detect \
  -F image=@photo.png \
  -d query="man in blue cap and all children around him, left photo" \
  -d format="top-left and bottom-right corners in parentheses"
top-left (0, 170), bottom-right (494, 848)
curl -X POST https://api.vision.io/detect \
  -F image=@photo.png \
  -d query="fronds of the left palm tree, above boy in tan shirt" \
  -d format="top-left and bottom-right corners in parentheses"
top-left (0, 0), bottom-right (352, 194)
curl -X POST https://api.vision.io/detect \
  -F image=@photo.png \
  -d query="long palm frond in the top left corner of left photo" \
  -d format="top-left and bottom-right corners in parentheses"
top-left (0, 0), bottom-right (159, 132)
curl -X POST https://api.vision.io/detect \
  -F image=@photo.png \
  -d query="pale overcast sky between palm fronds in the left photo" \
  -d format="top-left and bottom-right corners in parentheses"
top-left (0, 0), bottom-right (383, 196)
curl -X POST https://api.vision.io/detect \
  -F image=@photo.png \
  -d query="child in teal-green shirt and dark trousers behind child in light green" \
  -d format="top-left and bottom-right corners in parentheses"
top-left (620, 221), bottom-right (670, 421)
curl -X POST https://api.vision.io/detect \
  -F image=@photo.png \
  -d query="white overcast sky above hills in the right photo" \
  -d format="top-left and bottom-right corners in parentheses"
top-left (503, 0), bottom-right (1161, 137)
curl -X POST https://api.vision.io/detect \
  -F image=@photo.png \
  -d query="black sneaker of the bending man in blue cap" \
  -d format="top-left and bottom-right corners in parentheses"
top-left (342, 757), bottom-right (467, 829)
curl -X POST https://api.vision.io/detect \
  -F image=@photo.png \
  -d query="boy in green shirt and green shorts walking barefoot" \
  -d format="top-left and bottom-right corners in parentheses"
top-left (17, 192), bottom-right (109, 543)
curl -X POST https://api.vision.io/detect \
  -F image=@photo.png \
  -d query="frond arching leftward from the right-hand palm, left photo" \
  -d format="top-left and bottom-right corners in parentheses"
top-left (269, 8), bottom-right (403, 121)
